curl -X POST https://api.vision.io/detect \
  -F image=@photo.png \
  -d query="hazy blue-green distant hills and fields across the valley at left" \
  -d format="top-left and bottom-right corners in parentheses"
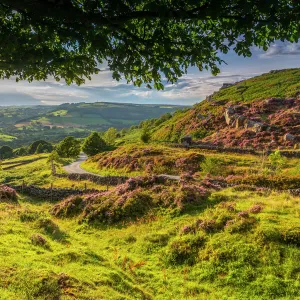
top-left (0, 102), bottom-right (185, 147)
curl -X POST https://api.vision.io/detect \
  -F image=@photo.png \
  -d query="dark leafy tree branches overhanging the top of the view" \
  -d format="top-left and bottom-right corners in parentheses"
top-left (0, 0), bottom-right (300, 89)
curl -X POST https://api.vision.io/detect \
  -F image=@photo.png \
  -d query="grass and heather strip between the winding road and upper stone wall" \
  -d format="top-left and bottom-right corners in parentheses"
top-left (81, 144), bottom-right (300, 178)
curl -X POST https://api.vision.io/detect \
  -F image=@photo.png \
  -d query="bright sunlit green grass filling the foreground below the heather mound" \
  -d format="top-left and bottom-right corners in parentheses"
top-left (0, 189), bottom-right (300, 300)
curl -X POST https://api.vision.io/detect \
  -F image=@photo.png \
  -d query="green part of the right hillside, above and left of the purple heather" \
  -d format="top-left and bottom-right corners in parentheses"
top-left (152, 69), bottom-right (300, 141)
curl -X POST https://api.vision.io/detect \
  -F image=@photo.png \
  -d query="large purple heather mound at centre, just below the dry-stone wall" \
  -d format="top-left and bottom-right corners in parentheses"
top-left (50, 176), bottom-right (210, 224)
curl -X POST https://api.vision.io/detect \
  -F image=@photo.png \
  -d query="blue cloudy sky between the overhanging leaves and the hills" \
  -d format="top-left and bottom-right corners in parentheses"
top-left (0, 42), bottom-right (300, 106)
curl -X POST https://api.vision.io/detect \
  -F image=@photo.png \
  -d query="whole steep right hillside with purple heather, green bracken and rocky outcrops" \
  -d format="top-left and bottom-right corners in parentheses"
top-left (146, 69), bottom-right (300, 148)
